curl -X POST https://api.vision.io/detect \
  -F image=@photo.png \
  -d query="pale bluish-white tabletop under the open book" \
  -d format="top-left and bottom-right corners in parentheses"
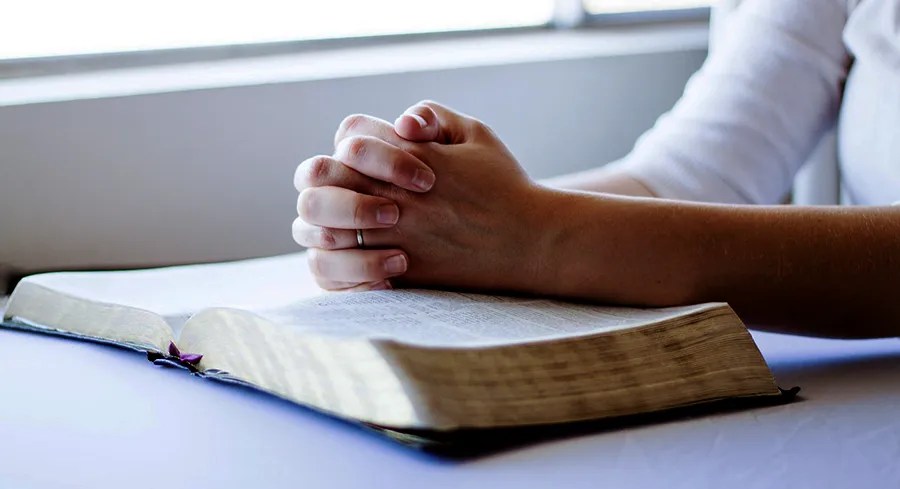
top-left (0, 320), bottom-right (900, 488)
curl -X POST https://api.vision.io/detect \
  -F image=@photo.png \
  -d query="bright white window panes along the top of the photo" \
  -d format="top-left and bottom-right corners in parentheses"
top-left (0, 0), bottom-right (709, 61)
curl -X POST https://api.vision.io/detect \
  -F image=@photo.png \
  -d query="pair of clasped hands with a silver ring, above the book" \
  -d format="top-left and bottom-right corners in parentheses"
top-left (293, 101), bottom-right (547, 290)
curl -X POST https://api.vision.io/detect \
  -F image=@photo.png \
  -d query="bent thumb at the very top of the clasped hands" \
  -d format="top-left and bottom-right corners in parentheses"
top-left (394, 101), bottom-right (470, 144)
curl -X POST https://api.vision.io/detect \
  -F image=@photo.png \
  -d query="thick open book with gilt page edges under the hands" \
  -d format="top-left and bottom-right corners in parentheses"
top-left (4, 253), bottom-right (780, 442)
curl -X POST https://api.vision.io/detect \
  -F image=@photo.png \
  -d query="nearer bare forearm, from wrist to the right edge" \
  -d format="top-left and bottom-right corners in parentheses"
top-left (534, 191), bottom-right (900, 337)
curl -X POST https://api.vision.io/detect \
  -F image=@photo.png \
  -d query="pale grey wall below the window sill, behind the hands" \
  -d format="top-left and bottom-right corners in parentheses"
top-left (0, 42), bottom-right (705, 269)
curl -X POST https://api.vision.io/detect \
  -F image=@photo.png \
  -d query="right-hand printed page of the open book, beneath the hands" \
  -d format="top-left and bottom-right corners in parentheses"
top-left (253, 290), bottom-right (718, 346)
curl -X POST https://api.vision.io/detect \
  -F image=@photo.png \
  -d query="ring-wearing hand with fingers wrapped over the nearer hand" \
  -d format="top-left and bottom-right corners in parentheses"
top-left (293, 102), bottom-right (439, 290)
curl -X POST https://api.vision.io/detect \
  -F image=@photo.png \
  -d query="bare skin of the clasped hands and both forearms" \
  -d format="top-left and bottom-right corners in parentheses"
top-left (294, 102), bottom-right (900, 338)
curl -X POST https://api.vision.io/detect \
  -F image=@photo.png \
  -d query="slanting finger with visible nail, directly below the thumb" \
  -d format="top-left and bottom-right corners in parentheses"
top-left (334, 136), bottom-right (435, 192)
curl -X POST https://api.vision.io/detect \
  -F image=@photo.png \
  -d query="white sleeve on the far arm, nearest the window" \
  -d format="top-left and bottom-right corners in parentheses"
top-left (619, 0), bottom-right (852, 204)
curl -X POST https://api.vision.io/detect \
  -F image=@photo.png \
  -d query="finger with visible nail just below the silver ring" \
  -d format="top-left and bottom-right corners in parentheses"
top-left (307, 248), bottom-right (409, 282)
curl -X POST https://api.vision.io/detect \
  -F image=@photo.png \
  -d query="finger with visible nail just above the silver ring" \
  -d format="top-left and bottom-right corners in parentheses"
top-left (297, 187), bottom-right (400, 229)
